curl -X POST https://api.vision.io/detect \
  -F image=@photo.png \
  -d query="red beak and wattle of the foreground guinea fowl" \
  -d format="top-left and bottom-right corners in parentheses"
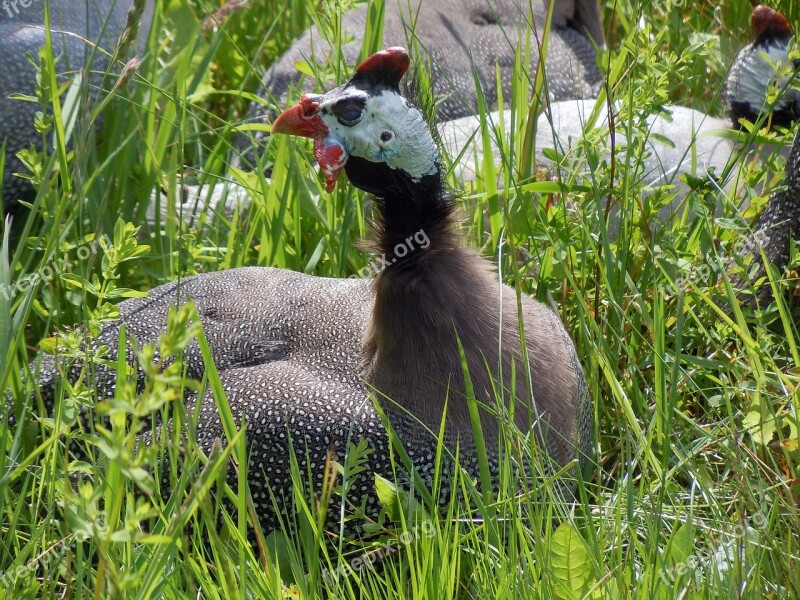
top-left (272, 96), bottom-right (349, 192)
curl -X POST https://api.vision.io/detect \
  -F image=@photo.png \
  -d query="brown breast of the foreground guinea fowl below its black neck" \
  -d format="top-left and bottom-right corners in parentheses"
top-left (363, 235), bottom-right (588, 465)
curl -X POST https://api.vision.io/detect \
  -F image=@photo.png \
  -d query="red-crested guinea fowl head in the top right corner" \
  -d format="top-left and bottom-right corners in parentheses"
top-left (727, 5), bottom-right (800, 127)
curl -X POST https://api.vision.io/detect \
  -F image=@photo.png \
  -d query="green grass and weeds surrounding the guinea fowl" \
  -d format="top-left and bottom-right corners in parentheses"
top-left (0, 0), bottom-right (800, 598)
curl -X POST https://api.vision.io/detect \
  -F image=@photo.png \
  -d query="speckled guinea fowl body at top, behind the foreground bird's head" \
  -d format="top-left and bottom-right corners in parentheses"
top-left (247, 0), bottom-right (605, 125)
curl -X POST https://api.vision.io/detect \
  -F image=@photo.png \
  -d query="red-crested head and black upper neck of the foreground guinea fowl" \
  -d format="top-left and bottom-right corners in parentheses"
top-left (272, 48), bottom-right (452, 248)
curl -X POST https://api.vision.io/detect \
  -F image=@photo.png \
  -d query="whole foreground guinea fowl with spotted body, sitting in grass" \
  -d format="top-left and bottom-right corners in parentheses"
top-left (28, 48), bottom-right (592, 528)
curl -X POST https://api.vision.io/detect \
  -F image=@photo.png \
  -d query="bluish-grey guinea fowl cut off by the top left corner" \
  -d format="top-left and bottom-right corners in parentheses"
top-left (0, 0), bottom-right (152, 212)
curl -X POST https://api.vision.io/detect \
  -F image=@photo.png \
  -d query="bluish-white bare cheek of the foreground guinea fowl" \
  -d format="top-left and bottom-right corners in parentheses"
top-left (326, 91), bottom-right (438, 181)
